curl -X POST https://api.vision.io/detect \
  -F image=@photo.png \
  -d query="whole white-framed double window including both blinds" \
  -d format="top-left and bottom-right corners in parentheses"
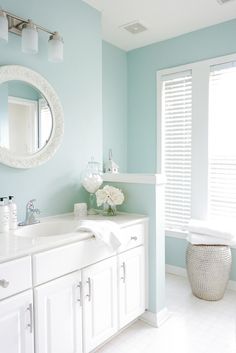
top-left (157, 55), bottom-right (236, 232)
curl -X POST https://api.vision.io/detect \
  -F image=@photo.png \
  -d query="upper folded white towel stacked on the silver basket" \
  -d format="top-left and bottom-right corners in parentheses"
top-left (188, 219), bottom-right (236, 241)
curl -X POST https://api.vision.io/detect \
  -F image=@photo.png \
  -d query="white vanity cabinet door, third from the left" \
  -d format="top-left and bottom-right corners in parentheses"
top-left (82, 257), bottom-right (117, 353)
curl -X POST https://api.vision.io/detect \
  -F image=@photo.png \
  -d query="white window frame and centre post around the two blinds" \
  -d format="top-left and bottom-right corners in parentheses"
top-left (156, 53), bottom-right (236, 239)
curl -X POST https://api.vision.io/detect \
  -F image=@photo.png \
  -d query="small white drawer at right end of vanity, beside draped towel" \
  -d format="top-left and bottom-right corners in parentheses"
top-left (118, 222), bottom-right (147, 253)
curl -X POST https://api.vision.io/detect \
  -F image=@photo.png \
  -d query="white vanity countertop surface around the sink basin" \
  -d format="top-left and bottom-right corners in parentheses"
top-left (0, 213), bottom-right (148, 263)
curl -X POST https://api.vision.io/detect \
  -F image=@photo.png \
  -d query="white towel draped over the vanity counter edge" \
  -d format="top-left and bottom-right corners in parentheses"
top-left (77, 220), bottom-right (121, 251)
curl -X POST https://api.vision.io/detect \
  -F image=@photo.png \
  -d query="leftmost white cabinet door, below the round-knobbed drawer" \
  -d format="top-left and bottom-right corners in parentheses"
top-left (0, 291), bottom-right (34, 353)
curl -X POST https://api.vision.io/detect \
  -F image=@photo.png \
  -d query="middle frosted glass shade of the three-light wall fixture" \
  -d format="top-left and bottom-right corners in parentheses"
top-left (21, 20), bottom-right (38, 54)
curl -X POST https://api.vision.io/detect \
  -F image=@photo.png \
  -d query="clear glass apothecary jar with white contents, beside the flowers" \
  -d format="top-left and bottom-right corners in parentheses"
top-left (82, 158), bottom-right (103, 215)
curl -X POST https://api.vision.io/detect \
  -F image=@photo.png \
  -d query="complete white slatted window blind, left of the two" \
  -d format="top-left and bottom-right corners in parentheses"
top-left (162, 70), bottom-right (192, 231)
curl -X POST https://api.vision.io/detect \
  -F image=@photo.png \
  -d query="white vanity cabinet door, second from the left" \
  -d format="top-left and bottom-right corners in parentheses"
top-left (35, 272), bottom-right (82, 353)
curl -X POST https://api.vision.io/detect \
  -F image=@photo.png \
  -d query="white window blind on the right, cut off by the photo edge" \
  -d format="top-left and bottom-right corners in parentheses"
top-left (208, 62), bottom-right (236, 219)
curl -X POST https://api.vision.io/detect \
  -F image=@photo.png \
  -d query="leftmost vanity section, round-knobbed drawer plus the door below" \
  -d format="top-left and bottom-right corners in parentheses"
top-left (0, 256), bottom-right (34, 353)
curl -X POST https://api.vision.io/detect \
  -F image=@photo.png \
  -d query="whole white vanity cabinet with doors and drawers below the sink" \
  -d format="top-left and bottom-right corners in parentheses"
top-left (0, 215), bottom-right (148, 353)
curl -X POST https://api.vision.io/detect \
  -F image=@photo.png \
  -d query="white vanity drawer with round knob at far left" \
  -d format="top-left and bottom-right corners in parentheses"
top-left (0, 256), bottom-right (32, 299)
